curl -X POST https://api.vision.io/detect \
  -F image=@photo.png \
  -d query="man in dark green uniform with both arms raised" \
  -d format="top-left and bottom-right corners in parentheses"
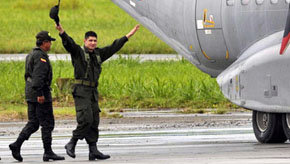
top-left (56, 25), bottom-right (139, 160)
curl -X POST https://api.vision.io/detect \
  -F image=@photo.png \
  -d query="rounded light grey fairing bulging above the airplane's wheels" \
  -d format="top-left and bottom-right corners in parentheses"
top-left (217, 44), bottom-right (290, 113)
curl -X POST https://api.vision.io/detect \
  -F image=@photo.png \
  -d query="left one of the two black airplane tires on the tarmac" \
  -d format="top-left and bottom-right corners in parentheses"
top-left (252, 111), bottom-right (287, 143)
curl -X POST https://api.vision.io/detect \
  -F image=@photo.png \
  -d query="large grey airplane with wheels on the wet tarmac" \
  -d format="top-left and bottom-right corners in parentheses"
top-left (111, 0), bottom-right (290, 143)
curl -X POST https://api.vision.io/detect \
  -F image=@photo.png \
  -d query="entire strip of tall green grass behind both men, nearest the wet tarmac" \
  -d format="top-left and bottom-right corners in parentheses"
top-left (0, 58), bottom-right (232, 109)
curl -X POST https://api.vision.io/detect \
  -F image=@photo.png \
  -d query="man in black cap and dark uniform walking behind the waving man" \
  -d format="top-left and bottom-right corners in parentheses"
top-left (9, 31), bottom-right (64, 162)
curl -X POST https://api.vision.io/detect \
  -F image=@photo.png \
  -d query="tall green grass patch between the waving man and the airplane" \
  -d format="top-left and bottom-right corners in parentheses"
top-left (99, 59), bottom-right (226, 108)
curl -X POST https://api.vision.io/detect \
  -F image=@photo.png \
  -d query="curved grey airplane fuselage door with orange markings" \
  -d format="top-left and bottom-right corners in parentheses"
top-left (196, 0), bottom-right (229, 70)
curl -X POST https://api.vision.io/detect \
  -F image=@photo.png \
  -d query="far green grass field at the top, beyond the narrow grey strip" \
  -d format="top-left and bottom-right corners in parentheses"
top-left (0, 0), bottom-right (175, 54)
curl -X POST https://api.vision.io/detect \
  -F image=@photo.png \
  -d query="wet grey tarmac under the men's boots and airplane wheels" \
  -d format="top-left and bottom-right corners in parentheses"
top-left (0, 110), bottom-right (290, 164)
